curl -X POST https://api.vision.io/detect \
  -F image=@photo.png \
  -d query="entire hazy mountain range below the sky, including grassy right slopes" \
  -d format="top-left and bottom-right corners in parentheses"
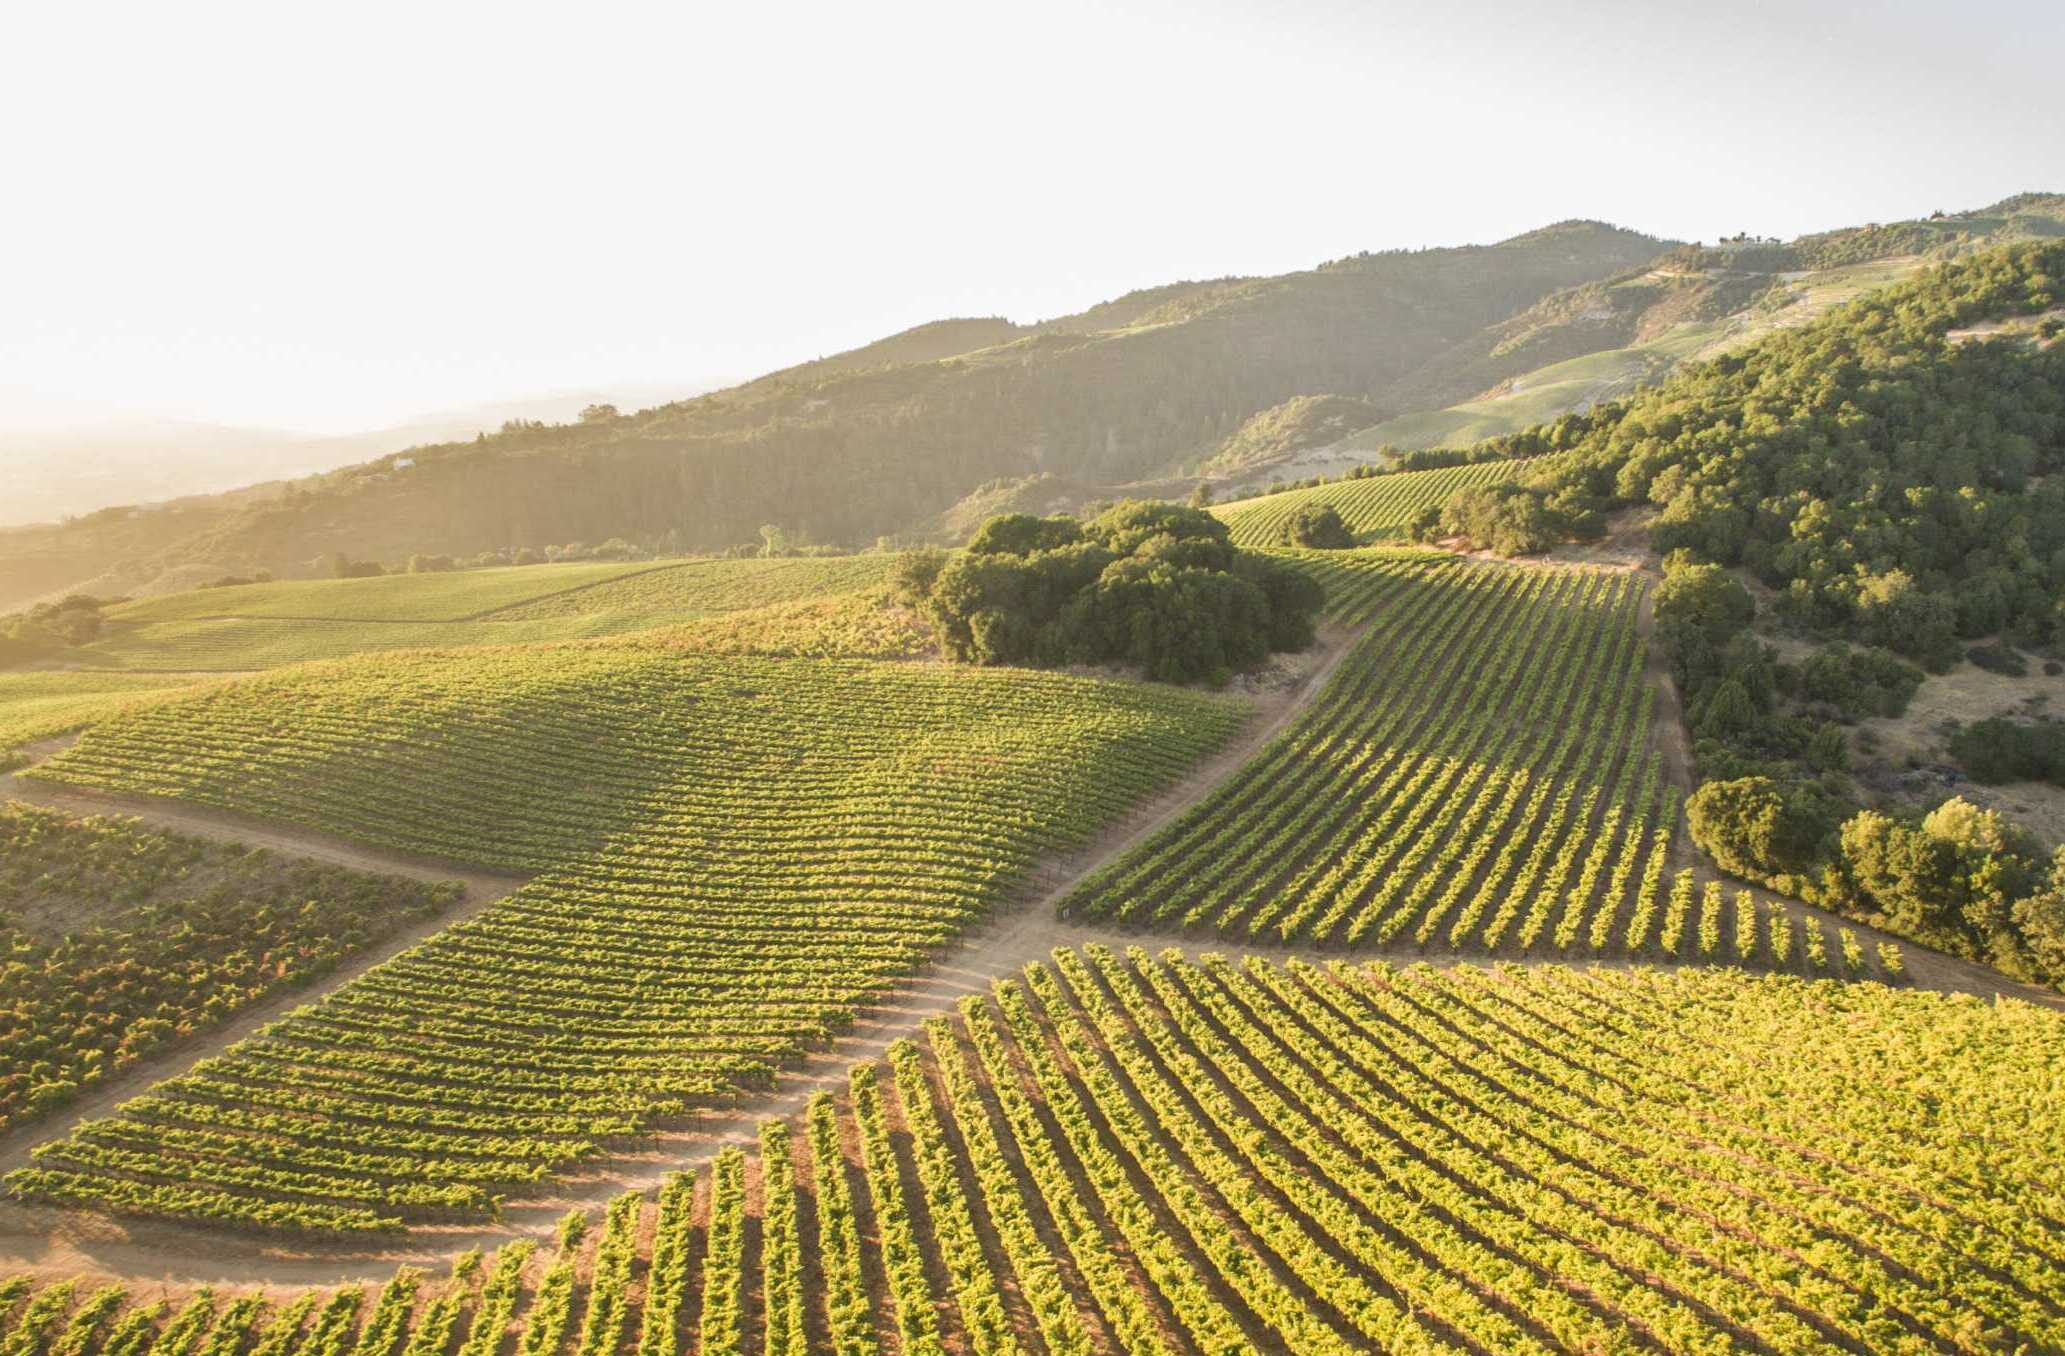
top-left (0, 194), bottom-right (2065, 609)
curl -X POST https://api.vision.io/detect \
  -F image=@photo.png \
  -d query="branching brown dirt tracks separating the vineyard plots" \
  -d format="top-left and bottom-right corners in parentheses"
top-left (0, 610), bottom-right (2057, 1294)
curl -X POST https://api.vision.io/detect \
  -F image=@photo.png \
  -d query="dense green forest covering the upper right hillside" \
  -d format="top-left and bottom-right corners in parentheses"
top-left (1528, 244), bottom-right (2065, 669)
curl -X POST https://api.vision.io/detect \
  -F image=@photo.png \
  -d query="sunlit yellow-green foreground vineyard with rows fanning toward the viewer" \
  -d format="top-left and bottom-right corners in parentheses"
top-left (0, 947), bottom-right (2065, 1356)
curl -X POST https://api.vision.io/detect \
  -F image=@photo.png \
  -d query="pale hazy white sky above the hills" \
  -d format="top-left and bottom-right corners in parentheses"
top-left (0, 0), bottom-right (2065, 431)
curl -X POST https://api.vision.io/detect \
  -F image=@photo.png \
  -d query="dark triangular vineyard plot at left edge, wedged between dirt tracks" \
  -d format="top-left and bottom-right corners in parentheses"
top-left (0, 803), bottom-right (458, 1131)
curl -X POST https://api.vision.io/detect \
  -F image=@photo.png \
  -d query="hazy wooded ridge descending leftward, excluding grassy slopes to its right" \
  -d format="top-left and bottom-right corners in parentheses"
top-left (0, 223), bottom-right (1662, 607)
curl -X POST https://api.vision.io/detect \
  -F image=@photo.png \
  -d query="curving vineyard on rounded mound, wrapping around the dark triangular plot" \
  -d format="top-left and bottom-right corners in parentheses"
top-left (8, 646), bottom-right (1249, 1232)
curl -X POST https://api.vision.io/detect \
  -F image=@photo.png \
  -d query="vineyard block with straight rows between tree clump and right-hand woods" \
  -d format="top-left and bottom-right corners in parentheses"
top-left (1063, 553), bottom-right (1900, 974)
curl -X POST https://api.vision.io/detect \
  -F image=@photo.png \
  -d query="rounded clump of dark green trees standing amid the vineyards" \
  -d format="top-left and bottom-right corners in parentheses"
top-left (896, 502), bottom-right (1324, 683)
